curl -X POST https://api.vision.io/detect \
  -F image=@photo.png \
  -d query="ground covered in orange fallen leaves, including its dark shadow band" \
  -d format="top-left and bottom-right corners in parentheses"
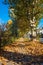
top-left (0, 40), bottom-right (43, 65)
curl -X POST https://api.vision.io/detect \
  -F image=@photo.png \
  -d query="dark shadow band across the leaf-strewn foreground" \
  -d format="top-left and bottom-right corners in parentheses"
top-left (0, 50), bottom-right (43, 65)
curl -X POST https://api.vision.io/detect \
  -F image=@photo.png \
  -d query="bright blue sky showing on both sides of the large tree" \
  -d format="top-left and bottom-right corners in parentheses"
top-left (0, 0), bottom-right (43, 27)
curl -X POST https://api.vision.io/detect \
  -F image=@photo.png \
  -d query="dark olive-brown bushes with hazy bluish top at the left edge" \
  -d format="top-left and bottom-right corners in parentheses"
top-left (0, 21), bottom-right (12, 48)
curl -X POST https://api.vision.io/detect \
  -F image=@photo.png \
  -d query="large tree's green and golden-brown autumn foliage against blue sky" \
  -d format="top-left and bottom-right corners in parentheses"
top-left (5, 0), bottom-right (43, 38)
